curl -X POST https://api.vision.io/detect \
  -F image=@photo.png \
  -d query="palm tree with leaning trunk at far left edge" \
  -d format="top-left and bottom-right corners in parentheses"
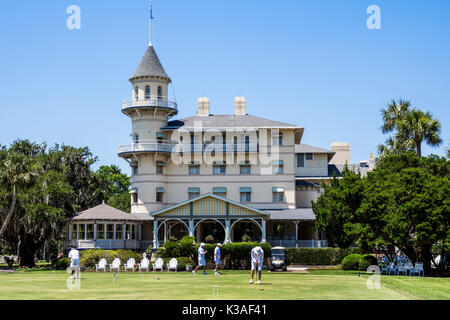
top-left (0, 152), bottom-right (37, 239)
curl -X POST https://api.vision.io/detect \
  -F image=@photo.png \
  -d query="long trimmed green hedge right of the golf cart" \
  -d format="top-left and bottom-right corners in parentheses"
top-left (286, 248), bottom-right (363, 266)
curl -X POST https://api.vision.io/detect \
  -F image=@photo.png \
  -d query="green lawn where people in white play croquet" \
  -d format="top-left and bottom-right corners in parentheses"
top-left (0, 270), bottom-right (450, 300)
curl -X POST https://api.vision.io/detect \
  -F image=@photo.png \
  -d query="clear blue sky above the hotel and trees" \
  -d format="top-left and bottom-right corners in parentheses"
top-left (0, 0), bottom-right (450, 173)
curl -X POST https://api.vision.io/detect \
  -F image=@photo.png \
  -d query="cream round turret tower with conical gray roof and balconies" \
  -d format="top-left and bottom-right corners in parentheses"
top-left (119, 6), bottom-right (178, 213)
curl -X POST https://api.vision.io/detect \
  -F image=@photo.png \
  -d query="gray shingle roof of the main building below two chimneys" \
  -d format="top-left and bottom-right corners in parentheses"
top-left (162, 114), bottom-right (301, 130)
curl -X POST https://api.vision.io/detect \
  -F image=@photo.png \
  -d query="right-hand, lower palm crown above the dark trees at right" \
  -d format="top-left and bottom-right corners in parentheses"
top-left (397, 109), bottom-right (442, 156)
